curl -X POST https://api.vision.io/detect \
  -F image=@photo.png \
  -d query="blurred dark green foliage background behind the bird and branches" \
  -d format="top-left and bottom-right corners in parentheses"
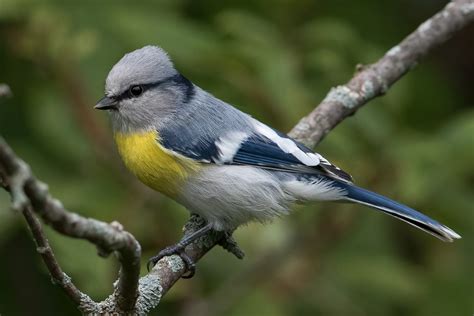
top-left (0, 0), bottom-right (474, 316)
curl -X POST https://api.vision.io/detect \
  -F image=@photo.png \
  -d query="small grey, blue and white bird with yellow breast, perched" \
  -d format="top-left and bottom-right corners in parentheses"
top-left (95, 46), bottom-right (461, 277)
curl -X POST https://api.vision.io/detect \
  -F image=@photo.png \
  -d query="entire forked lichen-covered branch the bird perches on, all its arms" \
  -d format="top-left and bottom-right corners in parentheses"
top-left (0, 0), bottom-right (474, 314)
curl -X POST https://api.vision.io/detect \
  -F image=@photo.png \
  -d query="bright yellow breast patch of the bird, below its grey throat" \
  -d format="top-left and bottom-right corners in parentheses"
top-left (115, 131), bottom-right (200, 197)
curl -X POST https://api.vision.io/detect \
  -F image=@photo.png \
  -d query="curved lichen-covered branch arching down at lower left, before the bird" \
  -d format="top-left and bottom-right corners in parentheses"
top-left (0, 137), bottom-right (141, 312)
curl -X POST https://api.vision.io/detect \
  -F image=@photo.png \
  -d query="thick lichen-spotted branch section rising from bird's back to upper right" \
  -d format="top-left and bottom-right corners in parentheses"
top-left (289, 0), bottom-right (474, 147)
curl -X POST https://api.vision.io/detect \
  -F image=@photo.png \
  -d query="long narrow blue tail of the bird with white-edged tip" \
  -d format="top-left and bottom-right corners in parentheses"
top-left (337, 181), bottom-right (461, 242)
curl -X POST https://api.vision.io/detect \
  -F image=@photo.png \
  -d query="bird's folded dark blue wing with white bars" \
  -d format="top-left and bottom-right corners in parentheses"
top-left (161, 121), bottom-right (352, 182)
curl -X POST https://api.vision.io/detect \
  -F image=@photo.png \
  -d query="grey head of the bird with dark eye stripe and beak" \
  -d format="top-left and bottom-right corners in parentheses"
top-left (95, 46), bottom-right (194, 132)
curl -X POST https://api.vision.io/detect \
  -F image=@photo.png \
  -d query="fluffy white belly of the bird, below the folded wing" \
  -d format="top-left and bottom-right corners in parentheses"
top-left (178, 166), bottom-right (295, 230)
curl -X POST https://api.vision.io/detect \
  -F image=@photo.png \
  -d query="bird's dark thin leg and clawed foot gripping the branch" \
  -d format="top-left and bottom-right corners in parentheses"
top-left (147, 224), bottom-right (212, 279)
